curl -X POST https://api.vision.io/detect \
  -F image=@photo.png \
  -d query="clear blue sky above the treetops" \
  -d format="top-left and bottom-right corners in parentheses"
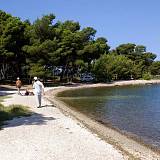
top-left (0, 0), bottom-right (160, 60)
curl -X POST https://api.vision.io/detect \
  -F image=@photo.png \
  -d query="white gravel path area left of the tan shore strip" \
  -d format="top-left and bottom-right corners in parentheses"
top-left (0, 89), bottom-right (126, 160)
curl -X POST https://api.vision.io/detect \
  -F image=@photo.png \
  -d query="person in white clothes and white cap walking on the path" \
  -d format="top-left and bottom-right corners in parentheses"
top-left (33, 77), bottom-right (44, 108)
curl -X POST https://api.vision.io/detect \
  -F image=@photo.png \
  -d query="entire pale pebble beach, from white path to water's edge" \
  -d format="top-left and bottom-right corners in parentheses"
top-left (0, 80), bottom-right (160, 160)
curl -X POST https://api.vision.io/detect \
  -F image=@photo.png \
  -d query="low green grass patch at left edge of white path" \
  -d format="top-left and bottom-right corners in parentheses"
top-left (0, 104), bottom-right (32, 125)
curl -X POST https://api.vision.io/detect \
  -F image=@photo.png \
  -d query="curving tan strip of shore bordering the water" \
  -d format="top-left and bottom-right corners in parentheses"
top-left (44, 80), bottom-right (160, 159)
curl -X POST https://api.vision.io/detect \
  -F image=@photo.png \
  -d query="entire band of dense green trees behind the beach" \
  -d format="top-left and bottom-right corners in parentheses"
top-left (0, 11), bottom-right (160, 81)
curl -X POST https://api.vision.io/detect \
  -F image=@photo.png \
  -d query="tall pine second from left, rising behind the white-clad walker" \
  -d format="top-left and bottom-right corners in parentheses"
top-left (23, 14), bottom-right (58, 77)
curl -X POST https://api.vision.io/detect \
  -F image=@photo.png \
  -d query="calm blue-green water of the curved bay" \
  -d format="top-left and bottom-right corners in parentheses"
top-left (58, 85), bottom-right (160, 148)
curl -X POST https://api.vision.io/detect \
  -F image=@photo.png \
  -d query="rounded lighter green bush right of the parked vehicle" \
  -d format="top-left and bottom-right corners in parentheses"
top-left (93, 54), bottom-right (133, 81)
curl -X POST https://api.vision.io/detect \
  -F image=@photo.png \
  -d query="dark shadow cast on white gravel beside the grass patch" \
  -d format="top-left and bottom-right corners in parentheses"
top-left (1, 113), bottom-right (57, 129)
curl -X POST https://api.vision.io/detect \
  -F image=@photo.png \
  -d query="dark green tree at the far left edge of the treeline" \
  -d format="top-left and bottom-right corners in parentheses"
top-left (0, 11), bottom-right (26, 79)
